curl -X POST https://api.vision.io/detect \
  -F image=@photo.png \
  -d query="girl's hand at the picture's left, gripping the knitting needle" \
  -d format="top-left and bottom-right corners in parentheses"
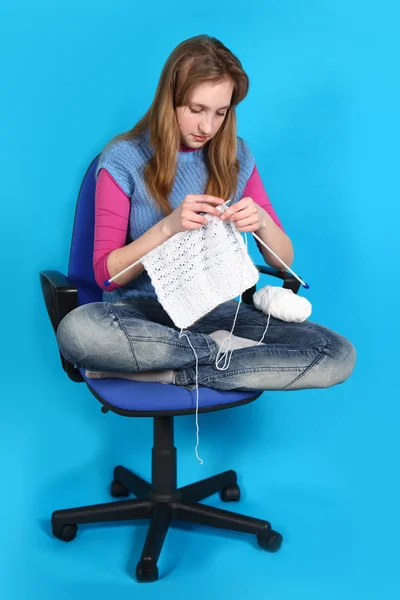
top-left (164, 194), bottom-right (225, 236)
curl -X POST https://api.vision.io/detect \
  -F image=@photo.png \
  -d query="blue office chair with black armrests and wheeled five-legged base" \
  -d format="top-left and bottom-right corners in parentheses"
top-left (40, 155), bottom-right (300, 582)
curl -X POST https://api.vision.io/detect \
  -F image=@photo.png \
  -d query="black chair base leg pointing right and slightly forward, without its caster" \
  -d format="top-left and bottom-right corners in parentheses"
top-left (174, 500), bottom-right (271, 536)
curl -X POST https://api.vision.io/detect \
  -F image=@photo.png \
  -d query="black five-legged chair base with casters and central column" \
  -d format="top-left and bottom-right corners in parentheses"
top-left (51, 417), bottom-right (282, 582)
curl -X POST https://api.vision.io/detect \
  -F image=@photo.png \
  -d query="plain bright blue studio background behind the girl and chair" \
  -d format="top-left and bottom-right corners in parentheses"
top-left (0, 0), bottom-right (400, 600)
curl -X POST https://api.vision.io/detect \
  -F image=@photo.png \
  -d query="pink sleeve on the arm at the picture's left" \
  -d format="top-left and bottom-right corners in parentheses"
top-left (93, 168), bottom-right (130, 292)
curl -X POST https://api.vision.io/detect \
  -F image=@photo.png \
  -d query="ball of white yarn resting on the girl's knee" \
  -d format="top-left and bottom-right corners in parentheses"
top-left (253, 285), bottom-right (312, 323)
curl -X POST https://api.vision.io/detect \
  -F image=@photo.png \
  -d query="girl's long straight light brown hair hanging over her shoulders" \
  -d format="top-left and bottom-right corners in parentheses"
top-left (107, 35), bottom-right (249, 214)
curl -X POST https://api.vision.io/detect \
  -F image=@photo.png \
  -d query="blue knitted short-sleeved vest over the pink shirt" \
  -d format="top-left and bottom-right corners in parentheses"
top-left (96, 132), bottom-right (255, 302)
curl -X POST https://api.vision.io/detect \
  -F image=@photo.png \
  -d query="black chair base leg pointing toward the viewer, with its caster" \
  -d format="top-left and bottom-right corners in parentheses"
top-left (136, 503), bottom-right (172, 581)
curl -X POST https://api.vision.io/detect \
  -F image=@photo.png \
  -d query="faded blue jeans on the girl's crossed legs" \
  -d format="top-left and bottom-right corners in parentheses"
top-left (57, 298), bottom-right (356, 390)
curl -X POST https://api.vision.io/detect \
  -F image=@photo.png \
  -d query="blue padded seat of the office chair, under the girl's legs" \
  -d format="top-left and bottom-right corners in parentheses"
top-left (80, 368), bottom-right (261, 417)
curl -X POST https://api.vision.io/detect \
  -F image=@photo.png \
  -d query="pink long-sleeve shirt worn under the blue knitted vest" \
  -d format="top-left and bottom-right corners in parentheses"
top-left (93, 147), bottom-right (283, 292)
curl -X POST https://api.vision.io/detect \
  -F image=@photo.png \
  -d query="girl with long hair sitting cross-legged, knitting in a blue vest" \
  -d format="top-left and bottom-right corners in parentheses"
top-left (57, 35), bottom-right (355, 390)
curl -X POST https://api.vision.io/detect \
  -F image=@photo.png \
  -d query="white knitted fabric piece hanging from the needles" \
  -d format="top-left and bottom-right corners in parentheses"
top-left (141, 210), bottom-right (259, 328)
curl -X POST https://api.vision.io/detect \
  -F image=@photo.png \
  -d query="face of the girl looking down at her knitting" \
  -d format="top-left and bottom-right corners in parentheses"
top-left (176, 79), bottom-right (233, 148)
